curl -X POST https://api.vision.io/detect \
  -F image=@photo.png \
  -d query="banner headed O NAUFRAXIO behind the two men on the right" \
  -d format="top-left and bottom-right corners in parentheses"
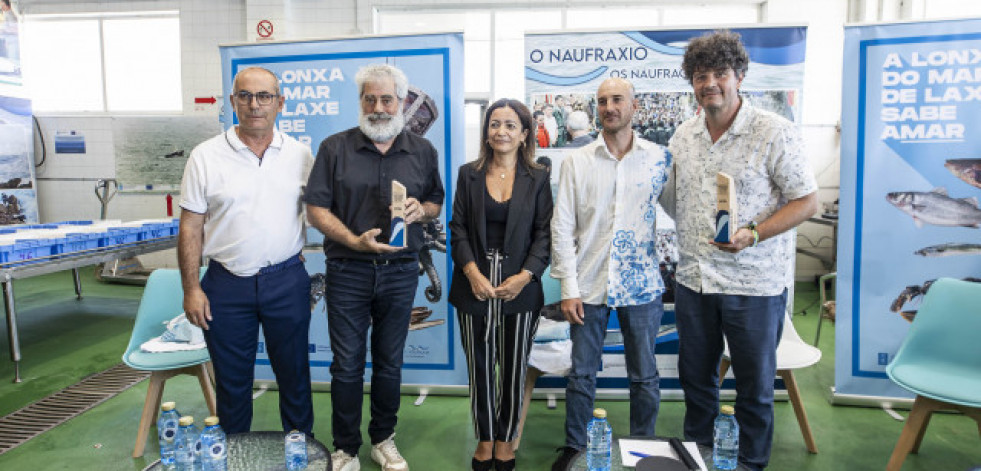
top-left (524, 26), bottom-right (807, 396)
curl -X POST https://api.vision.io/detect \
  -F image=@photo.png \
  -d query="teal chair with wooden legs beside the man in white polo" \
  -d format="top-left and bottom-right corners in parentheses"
top-left (123, 268), bottom-right (217, 458)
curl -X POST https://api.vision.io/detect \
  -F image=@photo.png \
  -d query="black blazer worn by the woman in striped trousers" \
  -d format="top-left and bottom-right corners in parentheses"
top-left (449, 162), bottom-right (552, 315)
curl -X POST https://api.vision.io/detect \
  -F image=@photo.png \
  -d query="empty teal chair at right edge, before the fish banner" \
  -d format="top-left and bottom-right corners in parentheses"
top-left (886, 278), bottom-right (981, 471)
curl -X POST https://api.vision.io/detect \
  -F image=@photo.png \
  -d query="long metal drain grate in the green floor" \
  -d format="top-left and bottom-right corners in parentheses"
top-left (0, 363), bottom-right (150, 455)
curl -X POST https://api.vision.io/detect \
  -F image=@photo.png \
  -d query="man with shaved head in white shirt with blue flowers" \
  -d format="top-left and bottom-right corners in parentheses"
top-left (552, 78), bottom-right (671, 471)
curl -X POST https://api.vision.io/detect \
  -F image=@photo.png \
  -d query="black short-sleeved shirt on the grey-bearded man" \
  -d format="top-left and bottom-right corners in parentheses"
top-left (303, 127), bottom-right (445, 259)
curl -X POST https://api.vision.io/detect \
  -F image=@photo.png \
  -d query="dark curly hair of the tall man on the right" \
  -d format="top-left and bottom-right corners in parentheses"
top-left (681, 30), bottom-right (749, 83)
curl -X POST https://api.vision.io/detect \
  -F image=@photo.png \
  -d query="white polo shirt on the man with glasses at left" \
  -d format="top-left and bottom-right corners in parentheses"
top-left (180, 128), bottom-right (313, 276)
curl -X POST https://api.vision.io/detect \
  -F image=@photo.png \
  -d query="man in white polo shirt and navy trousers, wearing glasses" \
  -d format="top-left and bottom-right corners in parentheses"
top-left (177, 67), bottom-right (313, 434)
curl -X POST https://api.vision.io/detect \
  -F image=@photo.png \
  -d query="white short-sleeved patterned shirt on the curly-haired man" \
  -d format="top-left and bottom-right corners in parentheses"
top-left (668, 99), bottom-right (817, 296)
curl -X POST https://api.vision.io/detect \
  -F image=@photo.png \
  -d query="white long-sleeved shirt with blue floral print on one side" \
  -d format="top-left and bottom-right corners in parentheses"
top-left (551, 133), bottom-right (671, 307)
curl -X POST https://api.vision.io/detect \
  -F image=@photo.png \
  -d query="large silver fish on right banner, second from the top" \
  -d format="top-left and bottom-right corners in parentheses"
top-left (886, 187), bottom-right (981, 227)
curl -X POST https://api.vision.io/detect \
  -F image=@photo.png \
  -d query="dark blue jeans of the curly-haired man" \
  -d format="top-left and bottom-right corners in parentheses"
top-left (675, 283), bottom-right (787, 469)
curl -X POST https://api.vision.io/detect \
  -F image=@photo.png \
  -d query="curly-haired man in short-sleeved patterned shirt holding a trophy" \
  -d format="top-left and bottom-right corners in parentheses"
top-left (664, 31), bottom-right (817, 469)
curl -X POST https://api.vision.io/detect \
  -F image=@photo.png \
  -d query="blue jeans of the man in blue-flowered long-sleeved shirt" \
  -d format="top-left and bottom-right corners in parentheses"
top-left (565, 302), bottom-right (664, 450)
